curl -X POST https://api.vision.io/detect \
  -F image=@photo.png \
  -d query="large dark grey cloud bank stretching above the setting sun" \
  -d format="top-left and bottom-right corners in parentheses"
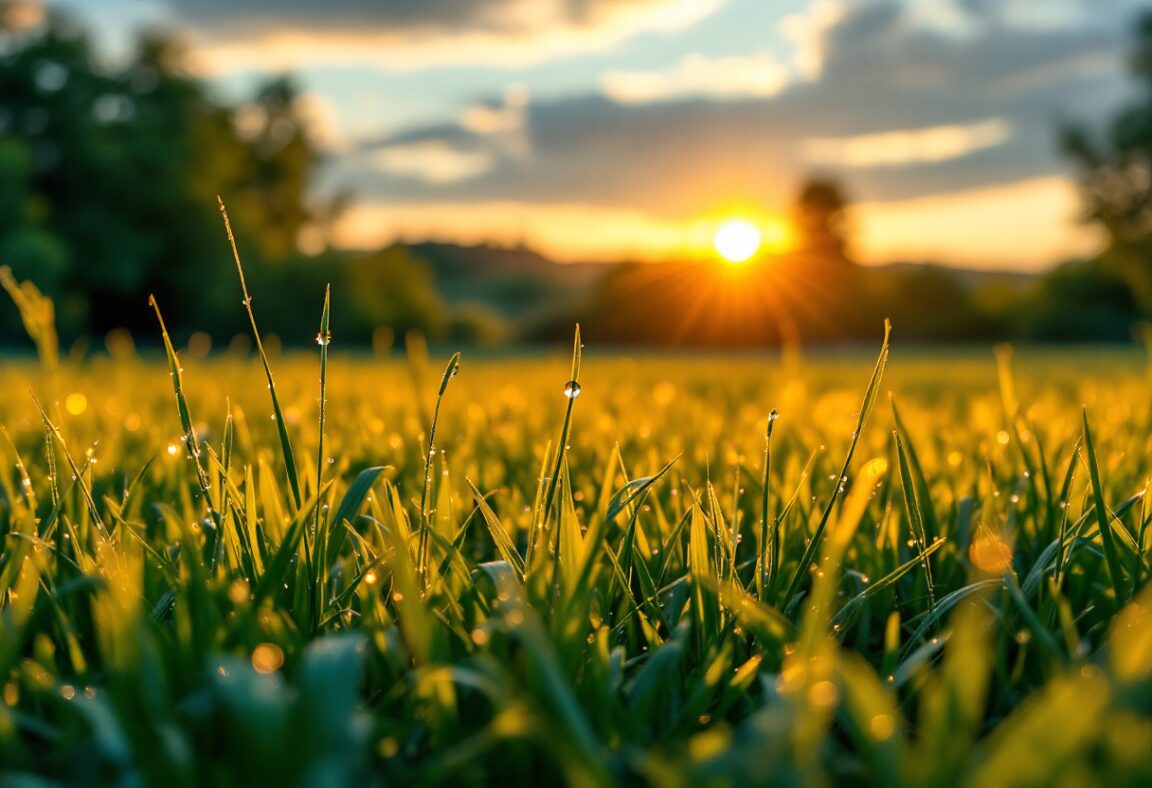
top-left (332, 2), bottom-right (1128, 214)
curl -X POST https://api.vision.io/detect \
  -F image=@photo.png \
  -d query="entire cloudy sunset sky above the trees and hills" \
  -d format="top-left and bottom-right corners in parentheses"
top-left (42, 0), bottom-right (1142, 270)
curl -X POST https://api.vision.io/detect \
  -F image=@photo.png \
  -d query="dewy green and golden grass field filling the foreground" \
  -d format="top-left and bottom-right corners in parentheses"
top-left (0, 262), bottom-right (1152, 786)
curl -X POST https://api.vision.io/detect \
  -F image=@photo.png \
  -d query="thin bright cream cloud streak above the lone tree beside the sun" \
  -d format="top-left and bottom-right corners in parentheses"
top-left (804, 118), bottom-right (1010, 168)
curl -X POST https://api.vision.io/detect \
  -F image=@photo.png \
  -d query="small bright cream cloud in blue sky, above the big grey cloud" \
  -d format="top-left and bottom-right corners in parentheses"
top-left (600, 52), bottom-right (790, 104)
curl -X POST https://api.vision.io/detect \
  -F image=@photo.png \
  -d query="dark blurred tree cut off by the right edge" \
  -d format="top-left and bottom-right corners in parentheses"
top-left (1062, 14), bottom-right (1152, 315)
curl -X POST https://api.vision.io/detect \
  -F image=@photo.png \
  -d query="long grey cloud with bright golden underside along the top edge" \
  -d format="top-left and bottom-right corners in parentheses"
top-left (164, 0), bottom-right (725, 75)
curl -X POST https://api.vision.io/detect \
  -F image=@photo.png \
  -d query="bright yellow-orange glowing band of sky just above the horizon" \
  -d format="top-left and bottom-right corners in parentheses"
top-left (331, 176), bottom-right (1100, 271)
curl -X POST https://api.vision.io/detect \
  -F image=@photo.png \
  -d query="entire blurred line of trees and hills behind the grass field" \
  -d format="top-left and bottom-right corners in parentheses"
top-left (0, 5), bottom-right (1152, 347)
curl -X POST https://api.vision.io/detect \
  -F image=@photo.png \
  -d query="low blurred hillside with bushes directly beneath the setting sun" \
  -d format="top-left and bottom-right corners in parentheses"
top-left (377, 242), bottom-right (1140, 347)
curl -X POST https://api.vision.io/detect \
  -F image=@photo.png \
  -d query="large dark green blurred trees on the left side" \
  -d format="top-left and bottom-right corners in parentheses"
top-left (0, 0), bottom-right (332, 334)
